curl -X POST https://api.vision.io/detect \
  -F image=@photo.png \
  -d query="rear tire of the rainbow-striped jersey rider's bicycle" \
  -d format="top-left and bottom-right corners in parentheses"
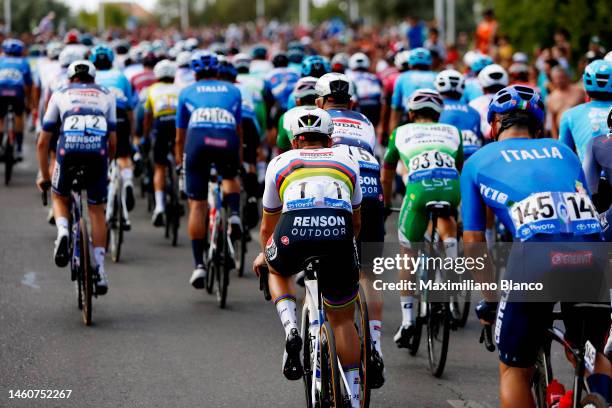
top-left (319, 322), bottom-right (344, 408)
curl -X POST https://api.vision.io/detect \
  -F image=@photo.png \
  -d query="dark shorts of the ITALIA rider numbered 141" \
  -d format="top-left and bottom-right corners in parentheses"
top-left (185, 135), bottom-right (240, 200)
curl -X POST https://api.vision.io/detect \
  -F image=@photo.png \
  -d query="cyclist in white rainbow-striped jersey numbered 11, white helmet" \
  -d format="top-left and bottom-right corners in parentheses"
top-left (254, 107), bottom-right (361, 407)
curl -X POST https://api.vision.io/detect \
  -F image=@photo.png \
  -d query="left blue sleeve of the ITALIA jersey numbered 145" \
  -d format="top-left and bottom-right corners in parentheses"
top-left (460, 160), bottom-right (487, 231)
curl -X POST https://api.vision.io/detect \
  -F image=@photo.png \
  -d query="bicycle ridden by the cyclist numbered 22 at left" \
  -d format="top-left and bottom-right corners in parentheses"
top-left (42, 166), bottom-right (98, 326)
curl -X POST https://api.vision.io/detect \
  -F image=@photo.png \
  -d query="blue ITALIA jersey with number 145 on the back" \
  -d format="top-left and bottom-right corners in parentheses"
top-left (461, 138), bottom-right (601, 241)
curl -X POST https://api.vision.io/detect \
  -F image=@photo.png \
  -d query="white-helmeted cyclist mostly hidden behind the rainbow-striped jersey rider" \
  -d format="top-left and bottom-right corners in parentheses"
top-left (316, 73), bottom-right (385, 388)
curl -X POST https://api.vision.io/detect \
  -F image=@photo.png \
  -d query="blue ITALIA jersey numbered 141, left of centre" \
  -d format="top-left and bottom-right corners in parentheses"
top-left (176, 80), bottom-right (242, 138)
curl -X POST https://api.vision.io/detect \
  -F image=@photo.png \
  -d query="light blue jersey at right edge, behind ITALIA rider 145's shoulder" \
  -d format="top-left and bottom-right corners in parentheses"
top-left (559, 101), bottom-right (612, 161)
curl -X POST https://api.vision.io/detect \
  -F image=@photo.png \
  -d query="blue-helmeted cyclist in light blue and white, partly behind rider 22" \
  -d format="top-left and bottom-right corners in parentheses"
top-left (89, 45), bottom-right (134, 230)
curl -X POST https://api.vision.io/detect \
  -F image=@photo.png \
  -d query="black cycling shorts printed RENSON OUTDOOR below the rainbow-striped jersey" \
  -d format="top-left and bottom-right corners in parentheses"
top-left (265, 208), bottom-right (359, 308)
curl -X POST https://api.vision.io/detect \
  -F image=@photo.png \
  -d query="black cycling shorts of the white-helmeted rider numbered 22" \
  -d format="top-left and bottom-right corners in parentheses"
top-left (51, 153), bottom-right (108, 204)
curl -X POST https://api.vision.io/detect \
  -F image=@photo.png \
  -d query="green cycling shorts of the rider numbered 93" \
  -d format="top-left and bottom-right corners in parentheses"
top-left (398, 179), bottom-right (461, 248)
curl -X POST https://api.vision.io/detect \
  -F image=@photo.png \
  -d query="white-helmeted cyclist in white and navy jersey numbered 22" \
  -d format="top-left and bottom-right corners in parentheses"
top-left (37, 60), bottom-right (117, 295)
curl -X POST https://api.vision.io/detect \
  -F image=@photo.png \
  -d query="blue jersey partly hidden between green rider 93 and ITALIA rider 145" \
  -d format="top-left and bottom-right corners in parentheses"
top-left (438, 98), bottom-right (483, 159)
